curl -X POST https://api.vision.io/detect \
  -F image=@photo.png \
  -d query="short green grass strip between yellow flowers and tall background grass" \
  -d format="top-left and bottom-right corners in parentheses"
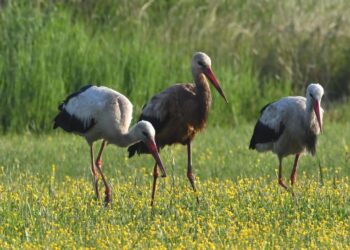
top-left (0, 121), bottom-right (350, 180)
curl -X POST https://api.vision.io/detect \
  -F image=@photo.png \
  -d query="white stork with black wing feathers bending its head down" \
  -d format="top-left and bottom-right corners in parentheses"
top-left (54, 85), bottom-right (166, 204)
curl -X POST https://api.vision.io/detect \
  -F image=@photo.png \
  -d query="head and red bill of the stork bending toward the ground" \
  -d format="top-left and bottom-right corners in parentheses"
top-left (135, 121), bottom-right (166, 177)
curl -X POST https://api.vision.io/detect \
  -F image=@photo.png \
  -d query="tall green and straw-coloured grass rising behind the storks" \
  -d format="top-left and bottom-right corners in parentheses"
top-left (0, 0), bottom-right (350, 132)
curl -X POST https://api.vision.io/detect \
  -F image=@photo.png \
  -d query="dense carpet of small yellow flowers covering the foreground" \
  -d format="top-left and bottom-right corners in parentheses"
top-left (0, 166), bottom-right (350, 249)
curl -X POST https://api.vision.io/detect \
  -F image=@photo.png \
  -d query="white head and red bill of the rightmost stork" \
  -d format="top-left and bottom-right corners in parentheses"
top-left (306, 83), bottom-right (324, 131)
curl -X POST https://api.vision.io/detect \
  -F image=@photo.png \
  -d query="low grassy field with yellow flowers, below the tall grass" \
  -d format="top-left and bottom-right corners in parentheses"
top-left (0, 123), bottom-right (350, 249)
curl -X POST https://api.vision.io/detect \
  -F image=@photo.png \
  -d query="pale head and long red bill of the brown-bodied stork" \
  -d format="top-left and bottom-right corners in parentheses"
top-left (192, 52), bottom-right (227, 102)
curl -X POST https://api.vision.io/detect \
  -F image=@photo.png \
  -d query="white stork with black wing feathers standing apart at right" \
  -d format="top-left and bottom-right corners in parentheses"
top-left (249, 83), bottom-right (324, 189)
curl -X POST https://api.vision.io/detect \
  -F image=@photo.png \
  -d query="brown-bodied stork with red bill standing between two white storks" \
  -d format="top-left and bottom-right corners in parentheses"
top-left (128, 52), bottom-right (227, 205)
